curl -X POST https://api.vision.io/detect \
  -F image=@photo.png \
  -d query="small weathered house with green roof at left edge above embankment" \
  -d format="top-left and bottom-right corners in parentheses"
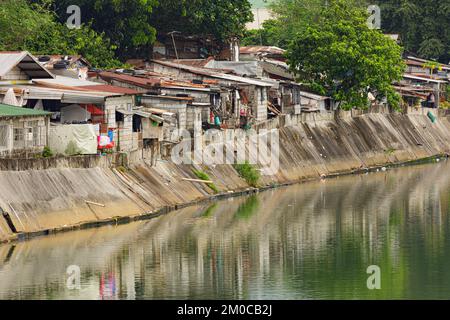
top-left (0, 104), bottom-right (50, 157)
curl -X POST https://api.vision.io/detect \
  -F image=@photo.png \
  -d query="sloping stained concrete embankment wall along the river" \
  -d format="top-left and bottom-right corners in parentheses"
top-left (0, 113), bottom-right (450, 241)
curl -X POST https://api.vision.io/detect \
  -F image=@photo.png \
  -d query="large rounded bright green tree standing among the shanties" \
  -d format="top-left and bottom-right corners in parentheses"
top-left (287, 0), bottom-right (405, 109)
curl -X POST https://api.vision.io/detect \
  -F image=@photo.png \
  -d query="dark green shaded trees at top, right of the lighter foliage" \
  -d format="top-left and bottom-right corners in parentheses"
top-left (45, 0), bottom-right (252, 60)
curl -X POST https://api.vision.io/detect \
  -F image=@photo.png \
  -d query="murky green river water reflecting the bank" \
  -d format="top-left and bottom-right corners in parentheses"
top-left (0, 162), bottom-right (450, 299)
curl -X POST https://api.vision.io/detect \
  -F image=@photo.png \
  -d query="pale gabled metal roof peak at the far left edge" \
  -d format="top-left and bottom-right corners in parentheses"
top-left (0, 51), bottom-right (54, 79)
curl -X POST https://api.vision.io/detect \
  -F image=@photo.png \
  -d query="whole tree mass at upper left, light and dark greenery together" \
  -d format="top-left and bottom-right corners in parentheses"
top-left (0, 0), bottom-right (253, 63)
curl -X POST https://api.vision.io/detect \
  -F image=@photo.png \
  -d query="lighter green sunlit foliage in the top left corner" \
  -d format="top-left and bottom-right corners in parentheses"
top-left (0, 0), bottom-right (120, 67)
